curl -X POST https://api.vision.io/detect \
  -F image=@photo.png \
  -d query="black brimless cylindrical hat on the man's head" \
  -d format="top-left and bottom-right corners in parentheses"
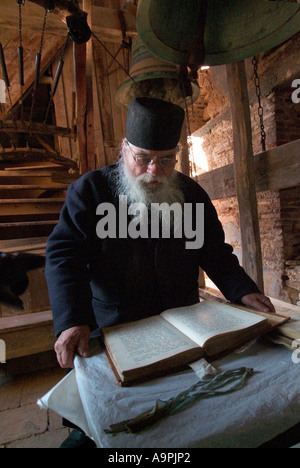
top-left (126, 97), bottom-right (185, 151)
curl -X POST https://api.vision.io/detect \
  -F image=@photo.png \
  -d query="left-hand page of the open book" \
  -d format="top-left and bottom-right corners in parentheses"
top-left (103, 315), bottom-right (197, 371)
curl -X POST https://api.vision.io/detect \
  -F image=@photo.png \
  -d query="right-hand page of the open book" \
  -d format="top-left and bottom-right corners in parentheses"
top-left (161, 301), bottom-right (266, 347)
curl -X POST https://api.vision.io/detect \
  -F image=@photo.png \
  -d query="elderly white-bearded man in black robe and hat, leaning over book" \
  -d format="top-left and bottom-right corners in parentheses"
top-left (46, 98), bottom-right (274, 368)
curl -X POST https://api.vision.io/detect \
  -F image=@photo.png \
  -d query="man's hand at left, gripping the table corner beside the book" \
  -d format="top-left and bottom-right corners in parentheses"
top-left (54, 325), bottom-right (91, 369)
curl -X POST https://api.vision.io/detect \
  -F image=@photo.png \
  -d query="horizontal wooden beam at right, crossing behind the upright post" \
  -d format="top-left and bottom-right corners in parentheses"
top-left (197, 140), bottom-right (300, 200)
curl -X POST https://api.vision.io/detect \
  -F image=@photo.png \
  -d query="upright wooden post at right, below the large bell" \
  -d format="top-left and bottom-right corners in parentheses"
top-left (227, 61), bottom-right (263, 292)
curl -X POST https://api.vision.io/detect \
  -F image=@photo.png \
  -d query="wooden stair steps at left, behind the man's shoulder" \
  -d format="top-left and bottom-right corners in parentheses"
top-left (0, 163), bottom-right (68, 240)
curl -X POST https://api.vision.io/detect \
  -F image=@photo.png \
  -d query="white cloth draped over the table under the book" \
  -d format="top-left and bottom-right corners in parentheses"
top-left (38, 339), bottom-right (300, 448)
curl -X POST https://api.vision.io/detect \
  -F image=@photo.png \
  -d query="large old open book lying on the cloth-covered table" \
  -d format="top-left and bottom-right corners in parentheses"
top-left (102, 301), bottom-right (288, 385)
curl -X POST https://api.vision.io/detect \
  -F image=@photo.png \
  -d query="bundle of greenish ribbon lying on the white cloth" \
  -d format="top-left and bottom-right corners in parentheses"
top-left (104, 367), bottom-right (253, 435)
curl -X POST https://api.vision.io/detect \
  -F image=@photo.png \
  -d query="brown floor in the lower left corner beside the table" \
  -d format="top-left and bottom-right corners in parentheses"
top-left (0, 367), bottom-right (69, 448)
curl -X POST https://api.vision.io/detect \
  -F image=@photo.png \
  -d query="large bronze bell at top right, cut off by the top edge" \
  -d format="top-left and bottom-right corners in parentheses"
top-left (137, 0), bottom-right (300, 68)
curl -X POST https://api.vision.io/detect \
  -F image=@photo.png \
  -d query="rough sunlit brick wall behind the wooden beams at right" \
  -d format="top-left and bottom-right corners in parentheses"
top-left (190, 34), bottom-right (300, 303)
